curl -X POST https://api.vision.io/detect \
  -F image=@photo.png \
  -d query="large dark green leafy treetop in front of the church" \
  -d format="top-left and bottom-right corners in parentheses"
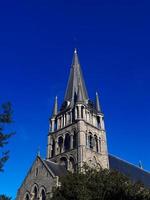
top-left (51, 166), bottom-right (150, 200)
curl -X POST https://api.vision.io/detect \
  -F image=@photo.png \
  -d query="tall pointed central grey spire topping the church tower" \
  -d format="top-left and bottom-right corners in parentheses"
top-left (64, 49), bottom-right (88, 103)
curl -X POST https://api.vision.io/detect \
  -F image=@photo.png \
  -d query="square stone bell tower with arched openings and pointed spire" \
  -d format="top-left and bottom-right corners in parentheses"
top-left (47, 49), bottom-right (109, 171)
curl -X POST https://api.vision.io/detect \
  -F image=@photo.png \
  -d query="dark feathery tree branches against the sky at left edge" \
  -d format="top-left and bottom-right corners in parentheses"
top-left (0, 102), bottom-right (13, 172)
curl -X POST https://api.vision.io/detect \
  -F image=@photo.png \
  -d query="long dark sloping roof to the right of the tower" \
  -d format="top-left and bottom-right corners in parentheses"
top-left (109, 154), bottom-right (150, 187)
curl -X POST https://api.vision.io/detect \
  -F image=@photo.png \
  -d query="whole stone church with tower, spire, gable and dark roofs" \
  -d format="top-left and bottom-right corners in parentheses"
top-left (17, 49), bottom-right (150, 200)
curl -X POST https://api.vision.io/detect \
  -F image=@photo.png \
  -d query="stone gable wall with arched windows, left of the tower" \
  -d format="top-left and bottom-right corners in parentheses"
top-left (17, 156), bottom-right (58, 200)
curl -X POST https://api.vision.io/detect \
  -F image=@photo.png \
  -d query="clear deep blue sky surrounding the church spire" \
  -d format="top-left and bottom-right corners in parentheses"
top-left (0, 0), bottom-right (150, 197)
